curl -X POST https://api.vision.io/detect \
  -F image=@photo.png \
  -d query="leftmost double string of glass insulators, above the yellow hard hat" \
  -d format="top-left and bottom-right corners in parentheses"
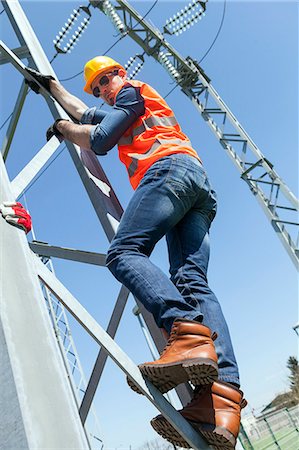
top-left (53, 6), bottom-right (91, 53)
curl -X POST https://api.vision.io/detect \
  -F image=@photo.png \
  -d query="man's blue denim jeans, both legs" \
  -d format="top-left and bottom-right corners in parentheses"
top-left (107, 153), bottom-right (239, 384)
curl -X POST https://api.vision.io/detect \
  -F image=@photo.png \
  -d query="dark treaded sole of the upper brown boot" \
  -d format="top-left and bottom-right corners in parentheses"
top-left (127, 358), bottom-right (218, 394)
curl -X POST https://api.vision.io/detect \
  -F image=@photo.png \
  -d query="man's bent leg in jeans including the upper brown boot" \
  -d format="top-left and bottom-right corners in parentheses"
top-left (107, 155), bottom-right (218, 392)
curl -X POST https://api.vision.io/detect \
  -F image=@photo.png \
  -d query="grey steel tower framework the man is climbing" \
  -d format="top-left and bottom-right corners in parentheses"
top-left (0, 1), bottom-right (210, 450)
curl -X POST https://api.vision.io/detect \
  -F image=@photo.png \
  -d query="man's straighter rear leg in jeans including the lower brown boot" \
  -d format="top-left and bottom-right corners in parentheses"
top-left (151, 167), bottom-right (247, 450)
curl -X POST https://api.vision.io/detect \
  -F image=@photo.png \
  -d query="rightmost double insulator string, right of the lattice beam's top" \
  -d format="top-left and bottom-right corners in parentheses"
top-left (164, 0), bottom-right (206, 36)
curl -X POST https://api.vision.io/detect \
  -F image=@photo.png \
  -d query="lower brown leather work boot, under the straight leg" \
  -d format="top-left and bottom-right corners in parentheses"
top-left (151, 381), bottom-right (247, 450)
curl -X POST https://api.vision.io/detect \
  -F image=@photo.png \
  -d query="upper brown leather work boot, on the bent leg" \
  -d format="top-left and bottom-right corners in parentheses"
top-left (128, 319), bottom-right (218, 394)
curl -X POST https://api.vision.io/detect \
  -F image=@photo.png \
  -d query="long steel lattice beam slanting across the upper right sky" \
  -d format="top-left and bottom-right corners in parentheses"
top-left (90, 0), bottom-right (299, 269)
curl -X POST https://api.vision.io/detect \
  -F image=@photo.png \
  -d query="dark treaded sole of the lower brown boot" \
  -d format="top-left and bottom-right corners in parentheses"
top-left (151, 416), bottom-right (236, 450)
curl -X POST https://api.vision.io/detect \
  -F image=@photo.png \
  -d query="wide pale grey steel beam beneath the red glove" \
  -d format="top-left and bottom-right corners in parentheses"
top-left (0, 156), bottom-right (89, 450)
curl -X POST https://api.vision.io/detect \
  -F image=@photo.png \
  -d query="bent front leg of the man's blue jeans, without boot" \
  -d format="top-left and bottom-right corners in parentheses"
top-left (107, 157), bottom-right (204, 333)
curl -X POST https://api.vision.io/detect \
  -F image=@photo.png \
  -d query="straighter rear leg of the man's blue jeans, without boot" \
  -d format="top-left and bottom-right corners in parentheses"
top-left (167, 207), bottom-right (240, 386)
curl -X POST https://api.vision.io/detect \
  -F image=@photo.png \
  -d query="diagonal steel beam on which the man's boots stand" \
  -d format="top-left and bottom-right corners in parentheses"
top-left (33, 256), bottom-right (210, 450)
